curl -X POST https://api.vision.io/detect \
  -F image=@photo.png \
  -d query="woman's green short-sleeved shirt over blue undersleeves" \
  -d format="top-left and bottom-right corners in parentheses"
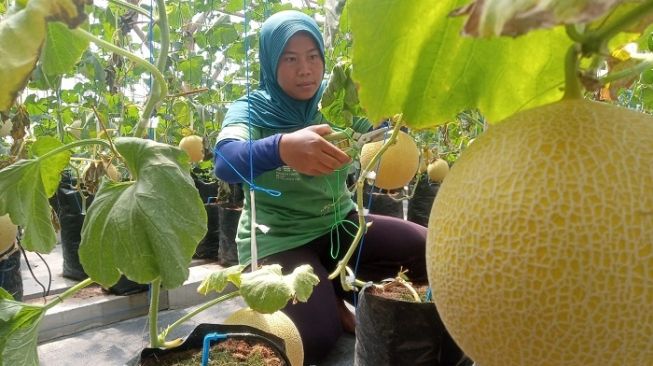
top-left (218, 120), bottom-right (370, 264)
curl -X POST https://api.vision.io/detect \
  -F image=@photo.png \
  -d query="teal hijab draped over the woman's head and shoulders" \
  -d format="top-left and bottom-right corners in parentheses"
top-left (223, 10), bottom-right (324, 130)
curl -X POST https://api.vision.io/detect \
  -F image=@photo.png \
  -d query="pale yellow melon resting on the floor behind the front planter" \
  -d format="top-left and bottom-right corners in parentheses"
top-left (224, 308), bottom-right (304, 366)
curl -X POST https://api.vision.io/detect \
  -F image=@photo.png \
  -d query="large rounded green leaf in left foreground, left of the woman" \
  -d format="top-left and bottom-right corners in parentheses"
top-left (79, 137), bottom-right (206, 288)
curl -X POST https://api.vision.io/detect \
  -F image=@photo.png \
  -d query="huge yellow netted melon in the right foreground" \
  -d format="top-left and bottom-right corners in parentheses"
top-left (427, 100), bottom-right (653, 366)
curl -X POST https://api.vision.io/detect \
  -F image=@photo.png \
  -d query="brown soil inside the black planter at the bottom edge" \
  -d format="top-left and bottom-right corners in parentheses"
top-left (142, 338), bottom-right (289, 366)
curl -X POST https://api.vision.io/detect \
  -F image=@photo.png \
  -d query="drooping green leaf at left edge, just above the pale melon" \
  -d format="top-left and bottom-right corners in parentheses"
top-left (0, 137), bottom-right (70, 253)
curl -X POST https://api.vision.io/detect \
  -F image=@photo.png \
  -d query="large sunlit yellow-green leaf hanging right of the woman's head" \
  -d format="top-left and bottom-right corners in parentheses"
top-left (348, 0), bottom-right (571, 128)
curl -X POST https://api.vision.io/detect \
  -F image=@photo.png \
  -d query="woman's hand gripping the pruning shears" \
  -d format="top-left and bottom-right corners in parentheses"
top-left (279, 124), bottom-right (351, 176)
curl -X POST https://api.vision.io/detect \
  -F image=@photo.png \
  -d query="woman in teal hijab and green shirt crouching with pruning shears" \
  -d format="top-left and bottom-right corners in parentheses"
top-left (215, 11), bottom-right (426, 364)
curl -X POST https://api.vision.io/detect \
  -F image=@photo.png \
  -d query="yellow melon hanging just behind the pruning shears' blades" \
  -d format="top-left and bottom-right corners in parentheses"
top-left (360, 131), bottom-right (419, 189)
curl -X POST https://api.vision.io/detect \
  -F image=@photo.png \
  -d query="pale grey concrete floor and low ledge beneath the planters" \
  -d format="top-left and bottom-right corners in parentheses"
top-left (21, 245), bottom-right (355, 366)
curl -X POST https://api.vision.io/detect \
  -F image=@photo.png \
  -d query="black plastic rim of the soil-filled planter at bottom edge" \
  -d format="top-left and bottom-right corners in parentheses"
top-left (126, 323), bottom-right (290, 366)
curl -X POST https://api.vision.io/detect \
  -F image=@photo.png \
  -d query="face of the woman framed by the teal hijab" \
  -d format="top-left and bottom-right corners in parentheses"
top-left (277, 32), bottom-right (324, 100)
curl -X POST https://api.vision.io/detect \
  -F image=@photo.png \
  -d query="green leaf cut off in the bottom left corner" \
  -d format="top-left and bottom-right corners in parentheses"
top-left (0, 288), bottom-right (45, 366)
